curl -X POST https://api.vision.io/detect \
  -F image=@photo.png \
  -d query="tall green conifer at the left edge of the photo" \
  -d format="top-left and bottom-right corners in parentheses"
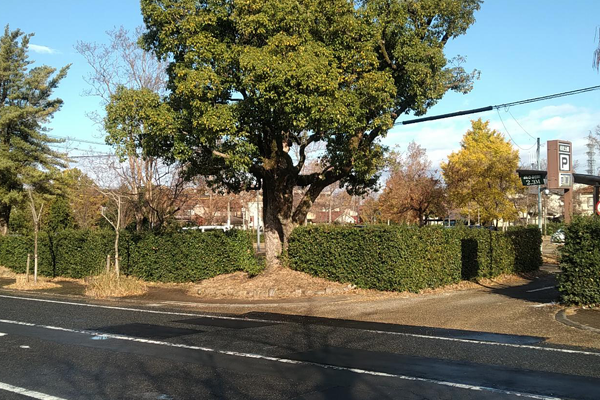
top-left (0, 25), bottom-right (69, 235)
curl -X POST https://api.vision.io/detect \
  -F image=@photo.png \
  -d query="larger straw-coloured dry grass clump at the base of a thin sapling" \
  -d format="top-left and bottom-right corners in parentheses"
top-left (85, 273), bottom-right (148, 298)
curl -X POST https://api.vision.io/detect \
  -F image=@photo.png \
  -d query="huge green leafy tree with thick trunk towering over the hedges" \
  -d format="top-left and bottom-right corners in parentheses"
top-left (141, 0), bottom-right (480, 266)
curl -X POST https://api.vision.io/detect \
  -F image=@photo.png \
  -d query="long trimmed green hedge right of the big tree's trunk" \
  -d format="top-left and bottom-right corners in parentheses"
top-left (288, 226), bottom-right (541, 292)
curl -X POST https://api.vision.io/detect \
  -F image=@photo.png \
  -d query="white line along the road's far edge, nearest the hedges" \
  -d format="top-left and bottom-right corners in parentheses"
top-left (0, 295), bottom-right (600, 357)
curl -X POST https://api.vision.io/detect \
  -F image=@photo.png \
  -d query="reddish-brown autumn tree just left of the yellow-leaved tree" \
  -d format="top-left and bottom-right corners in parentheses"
top-left (379, 142), bottom-right (446, 225)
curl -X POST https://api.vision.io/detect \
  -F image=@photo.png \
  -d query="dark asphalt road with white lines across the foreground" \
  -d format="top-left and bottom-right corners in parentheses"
top-left (0, 292), bottom-right (600, 400)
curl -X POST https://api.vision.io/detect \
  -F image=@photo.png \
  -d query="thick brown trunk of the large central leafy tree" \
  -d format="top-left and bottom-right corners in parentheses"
top-left (263, 179), bottom-right (296, 272)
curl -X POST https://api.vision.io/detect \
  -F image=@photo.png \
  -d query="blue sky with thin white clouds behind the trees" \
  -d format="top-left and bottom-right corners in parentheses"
top-left (0, 0), bottom-right (600, 172)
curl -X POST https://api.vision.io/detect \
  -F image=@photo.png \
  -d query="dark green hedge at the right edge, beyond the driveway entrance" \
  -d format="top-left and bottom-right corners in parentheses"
top-left (558, 217), bottom-right (600, 305)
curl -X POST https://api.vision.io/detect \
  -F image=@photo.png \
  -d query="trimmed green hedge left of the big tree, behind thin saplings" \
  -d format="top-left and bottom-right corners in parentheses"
top-left (0, 230), bottom-right (259, 282)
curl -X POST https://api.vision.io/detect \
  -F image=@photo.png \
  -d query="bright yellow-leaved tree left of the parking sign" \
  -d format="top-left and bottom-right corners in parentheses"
top-left (441, 119), bottom-right (523, 224)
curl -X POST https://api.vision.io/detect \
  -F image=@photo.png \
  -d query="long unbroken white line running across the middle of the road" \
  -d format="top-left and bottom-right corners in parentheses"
top-left (0, 319), bottom-right (564, 400)
